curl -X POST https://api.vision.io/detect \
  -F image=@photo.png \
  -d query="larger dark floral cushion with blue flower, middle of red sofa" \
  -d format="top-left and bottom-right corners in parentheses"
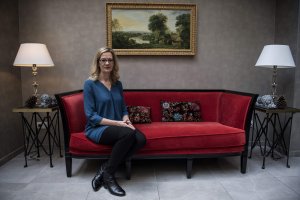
top-left (161, 101), bottom-right (201, 122)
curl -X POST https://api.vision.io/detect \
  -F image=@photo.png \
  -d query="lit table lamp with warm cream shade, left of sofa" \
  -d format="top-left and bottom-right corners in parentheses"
top-left (13, 43), bottom-right (54, 97)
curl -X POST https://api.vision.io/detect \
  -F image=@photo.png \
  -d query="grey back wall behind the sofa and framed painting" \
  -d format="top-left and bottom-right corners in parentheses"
top-left (0, 0), bottom-right (300, 164)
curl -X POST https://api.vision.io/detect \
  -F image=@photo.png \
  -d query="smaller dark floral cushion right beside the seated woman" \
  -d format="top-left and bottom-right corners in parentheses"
top-left (127, 106), bottom-right (151, 124)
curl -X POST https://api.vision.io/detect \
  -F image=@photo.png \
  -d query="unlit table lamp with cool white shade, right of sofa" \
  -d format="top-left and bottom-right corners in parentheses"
top-left (255, 44), bottom-right (296, 100)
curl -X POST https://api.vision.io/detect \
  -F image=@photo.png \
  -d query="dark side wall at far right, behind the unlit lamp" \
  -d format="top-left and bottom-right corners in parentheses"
top-left (275, 0), bottom-right (300, 155)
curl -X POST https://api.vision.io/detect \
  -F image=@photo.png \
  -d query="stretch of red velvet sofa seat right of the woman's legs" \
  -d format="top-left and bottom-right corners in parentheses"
top-left (135, 122), bottom-right (246, 152)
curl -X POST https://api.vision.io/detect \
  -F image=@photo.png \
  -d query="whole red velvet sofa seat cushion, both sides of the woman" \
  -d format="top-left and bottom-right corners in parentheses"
top-left (70, 122), bottom-right (245, 154)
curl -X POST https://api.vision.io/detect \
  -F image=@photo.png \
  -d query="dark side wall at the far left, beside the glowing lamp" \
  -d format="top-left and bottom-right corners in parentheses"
top-left (0, 0), bottom-right (23, 165)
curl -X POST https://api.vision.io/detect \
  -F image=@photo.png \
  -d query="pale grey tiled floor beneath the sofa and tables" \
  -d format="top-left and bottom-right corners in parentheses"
top-left (0, 149), bottom-right (300, 200)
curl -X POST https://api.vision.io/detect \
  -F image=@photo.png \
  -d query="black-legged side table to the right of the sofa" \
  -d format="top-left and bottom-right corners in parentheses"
top-left (249, 106), bottom-right (300, 169)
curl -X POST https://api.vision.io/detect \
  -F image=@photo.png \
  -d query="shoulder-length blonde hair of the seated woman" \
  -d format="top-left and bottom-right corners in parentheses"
top-left (89, 47), bottom-right (120, 84)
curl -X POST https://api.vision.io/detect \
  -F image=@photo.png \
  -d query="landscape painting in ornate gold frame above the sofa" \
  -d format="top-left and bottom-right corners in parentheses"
top-left (106, 3), bottom-right (197, 55)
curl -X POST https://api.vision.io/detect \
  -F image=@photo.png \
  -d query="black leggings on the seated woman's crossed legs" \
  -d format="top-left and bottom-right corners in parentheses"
top-left (99, 126), bottom-right (146, 174)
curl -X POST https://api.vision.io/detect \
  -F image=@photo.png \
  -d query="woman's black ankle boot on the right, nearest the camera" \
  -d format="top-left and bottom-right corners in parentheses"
top-left (103, 172), bottom-right (126, 196)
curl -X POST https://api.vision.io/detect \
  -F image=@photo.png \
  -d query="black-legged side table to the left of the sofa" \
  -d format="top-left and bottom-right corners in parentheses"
top-left (12, 106), bottom-right (62, 167)
